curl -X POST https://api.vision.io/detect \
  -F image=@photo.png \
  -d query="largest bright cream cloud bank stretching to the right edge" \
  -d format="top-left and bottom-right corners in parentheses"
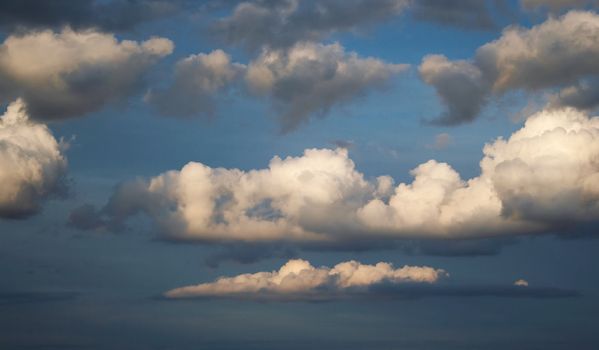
top-left (71, 108), bottom-right (599, 244)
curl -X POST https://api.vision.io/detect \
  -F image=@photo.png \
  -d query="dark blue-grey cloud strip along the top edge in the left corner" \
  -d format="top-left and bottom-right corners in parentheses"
top-left (0, 0), bottom-right (184, 31)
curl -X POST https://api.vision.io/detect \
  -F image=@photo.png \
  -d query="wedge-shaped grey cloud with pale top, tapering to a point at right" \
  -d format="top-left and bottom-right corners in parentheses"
top-left (245, 43), bottom-right (407, 131)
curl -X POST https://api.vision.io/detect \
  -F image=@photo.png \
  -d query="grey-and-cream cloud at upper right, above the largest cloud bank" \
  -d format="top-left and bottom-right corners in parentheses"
top-left (419, 11), bottom-right (599, 125)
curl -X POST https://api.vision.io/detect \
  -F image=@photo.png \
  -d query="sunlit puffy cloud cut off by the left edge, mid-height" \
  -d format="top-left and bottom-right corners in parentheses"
top-left (0, 100), bottom-right (67, 218)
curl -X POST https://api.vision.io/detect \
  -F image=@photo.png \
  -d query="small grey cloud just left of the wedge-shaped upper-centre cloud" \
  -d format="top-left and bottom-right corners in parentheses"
top-left (146, 50), bottom-right (245, 117)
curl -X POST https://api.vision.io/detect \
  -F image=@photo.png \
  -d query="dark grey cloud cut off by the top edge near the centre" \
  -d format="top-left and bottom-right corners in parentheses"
top-left (213, 0), bottom-right (409, 51)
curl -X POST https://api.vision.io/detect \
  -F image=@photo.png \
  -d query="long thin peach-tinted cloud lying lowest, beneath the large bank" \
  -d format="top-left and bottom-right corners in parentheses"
top-left (164, 259), bottom-right (448, 299)
